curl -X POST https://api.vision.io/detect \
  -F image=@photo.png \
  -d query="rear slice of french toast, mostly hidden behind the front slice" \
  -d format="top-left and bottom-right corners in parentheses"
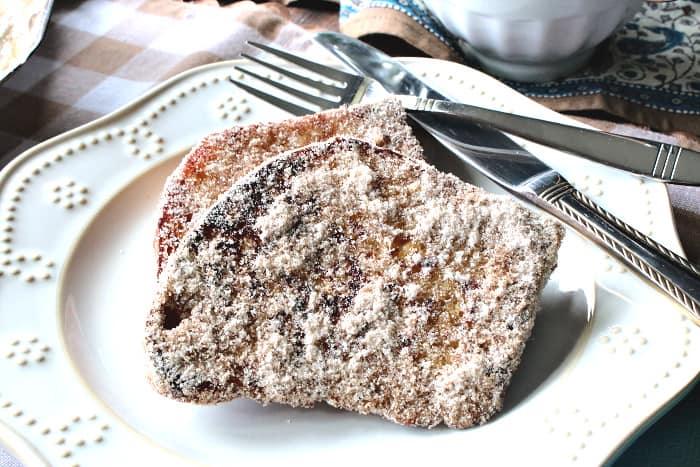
top-left (154, 99), bottom-right (422, 273)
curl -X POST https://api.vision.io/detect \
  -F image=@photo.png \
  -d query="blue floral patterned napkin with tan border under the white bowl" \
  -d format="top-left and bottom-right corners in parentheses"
top-left (340, 0), bottom-right (700, 135)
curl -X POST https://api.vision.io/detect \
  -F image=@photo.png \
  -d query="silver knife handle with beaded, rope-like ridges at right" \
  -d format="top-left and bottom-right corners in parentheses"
top-left (521, 178), bottom-right (700, 325)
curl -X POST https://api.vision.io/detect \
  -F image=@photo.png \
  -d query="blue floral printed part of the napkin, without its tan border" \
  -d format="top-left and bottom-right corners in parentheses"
top-left (340, 0), bottom-right (700, 115)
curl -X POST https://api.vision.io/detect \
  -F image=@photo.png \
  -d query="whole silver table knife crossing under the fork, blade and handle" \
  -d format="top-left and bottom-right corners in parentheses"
top-left (316, 32), bottom-right (700, 325)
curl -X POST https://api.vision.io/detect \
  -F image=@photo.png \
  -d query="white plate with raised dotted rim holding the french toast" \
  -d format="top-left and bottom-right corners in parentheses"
top-left (0, 59), bottom-right (700, 465)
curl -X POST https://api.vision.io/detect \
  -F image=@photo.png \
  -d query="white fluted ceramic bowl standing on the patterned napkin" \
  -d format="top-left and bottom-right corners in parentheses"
top-left (424, 0), bottom-right (643, 81)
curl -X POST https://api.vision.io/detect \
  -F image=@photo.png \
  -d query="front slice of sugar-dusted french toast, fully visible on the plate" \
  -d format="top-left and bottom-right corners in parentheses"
top-left (146, 138), bottom-right (563, 428)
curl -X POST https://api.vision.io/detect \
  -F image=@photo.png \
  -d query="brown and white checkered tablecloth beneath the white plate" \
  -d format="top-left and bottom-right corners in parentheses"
top-left (0, 0), bottom-right (700, 467)
